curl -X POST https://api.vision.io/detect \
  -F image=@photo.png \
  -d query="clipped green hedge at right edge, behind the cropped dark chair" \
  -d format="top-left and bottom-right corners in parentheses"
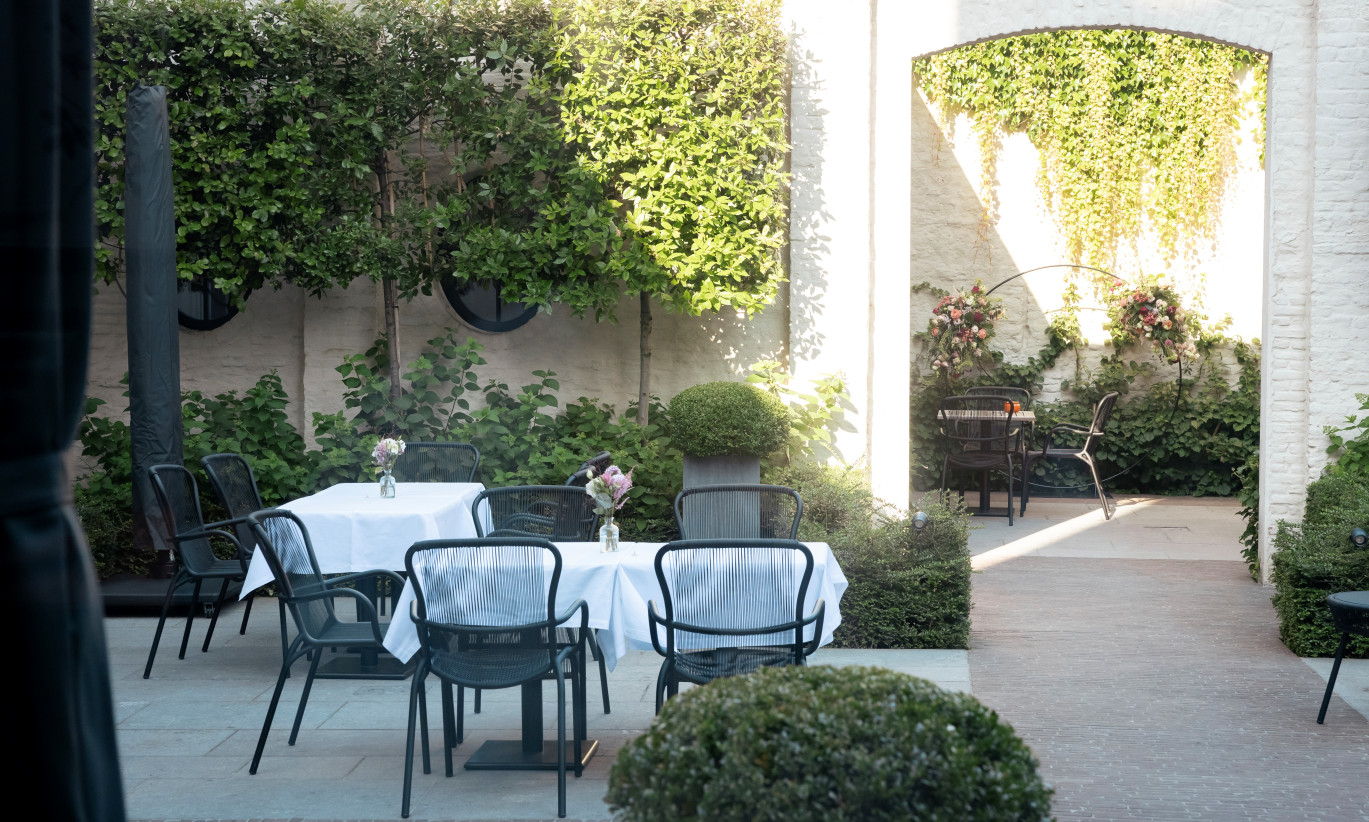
top-left (1273, 475), bottom-right (1369, 658)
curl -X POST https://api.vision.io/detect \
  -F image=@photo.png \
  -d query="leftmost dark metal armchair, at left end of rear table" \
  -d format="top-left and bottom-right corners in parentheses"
top-left (142, 464), bottom-right (248, 680)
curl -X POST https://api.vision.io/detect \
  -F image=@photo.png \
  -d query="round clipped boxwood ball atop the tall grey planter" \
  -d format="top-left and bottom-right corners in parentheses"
top-left (669, 382), bottom-right (789, 456)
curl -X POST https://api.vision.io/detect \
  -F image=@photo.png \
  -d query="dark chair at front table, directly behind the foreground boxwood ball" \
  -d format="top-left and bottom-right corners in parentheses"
top-left (646, 540), bottom-right (827, 714)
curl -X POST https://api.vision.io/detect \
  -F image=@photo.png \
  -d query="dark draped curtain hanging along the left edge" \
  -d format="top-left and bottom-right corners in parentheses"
top-left (0, 0), bottom-right (125, 822)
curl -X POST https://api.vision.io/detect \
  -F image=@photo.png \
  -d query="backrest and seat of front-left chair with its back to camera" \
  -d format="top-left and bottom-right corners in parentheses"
top-left (404, 537), bottom-right (561, 688)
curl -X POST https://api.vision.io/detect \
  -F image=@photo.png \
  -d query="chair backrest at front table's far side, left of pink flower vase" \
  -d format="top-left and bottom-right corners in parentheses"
top-left (471, 485), bottom-right (598, 543)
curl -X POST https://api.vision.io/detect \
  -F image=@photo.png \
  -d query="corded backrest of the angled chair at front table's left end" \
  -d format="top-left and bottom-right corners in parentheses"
top-left (248, 508), bottom-right (337, 636)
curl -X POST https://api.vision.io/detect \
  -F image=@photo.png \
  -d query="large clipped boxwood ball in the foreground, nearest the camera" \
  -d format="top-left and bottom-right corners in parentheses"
top-left (608, 666), bottom-right (1051, 822)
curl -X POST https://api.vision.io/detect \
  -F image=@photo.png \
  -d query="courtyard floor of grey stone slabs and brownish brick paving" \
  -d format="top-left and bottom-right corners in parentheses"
top-left (105, 497), bottom-right (1369, 819)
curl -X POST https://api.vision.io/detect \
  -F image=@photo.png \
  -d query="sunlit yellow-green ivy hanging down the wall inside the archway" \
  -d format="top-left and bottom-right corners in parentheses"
top-left (914, 30), bottom-right (1268, 278)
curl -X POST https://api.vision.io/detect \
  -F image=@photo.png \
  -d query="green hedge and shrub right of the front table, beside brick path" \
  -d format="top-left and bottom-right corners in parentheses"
top-left (765, 463), bottom-right (971, 648)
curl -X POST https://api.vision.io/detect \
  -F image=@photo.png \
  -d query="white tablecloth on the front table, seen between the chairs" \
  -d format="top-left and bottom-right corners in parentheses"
top-left (385, 543), bottom-right (846, 670)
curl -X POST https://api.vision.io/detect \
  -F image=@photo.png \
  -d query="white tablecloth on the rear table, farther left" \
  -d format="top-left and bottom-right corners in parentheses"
top-left (242, 482), bottom-right (485, 596)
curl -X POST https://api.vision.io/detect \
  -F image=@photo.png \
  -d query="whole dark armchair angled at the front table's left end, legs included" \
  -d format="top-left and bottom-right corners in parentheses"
top-left (248, 508), bottom-right (402, 774)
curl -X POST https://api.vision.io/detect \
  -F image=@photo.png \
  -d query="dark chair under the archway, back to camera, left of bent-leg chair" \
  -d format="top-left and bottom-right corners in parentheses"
top-left (936, 395), bottom-right (1023, 525)
